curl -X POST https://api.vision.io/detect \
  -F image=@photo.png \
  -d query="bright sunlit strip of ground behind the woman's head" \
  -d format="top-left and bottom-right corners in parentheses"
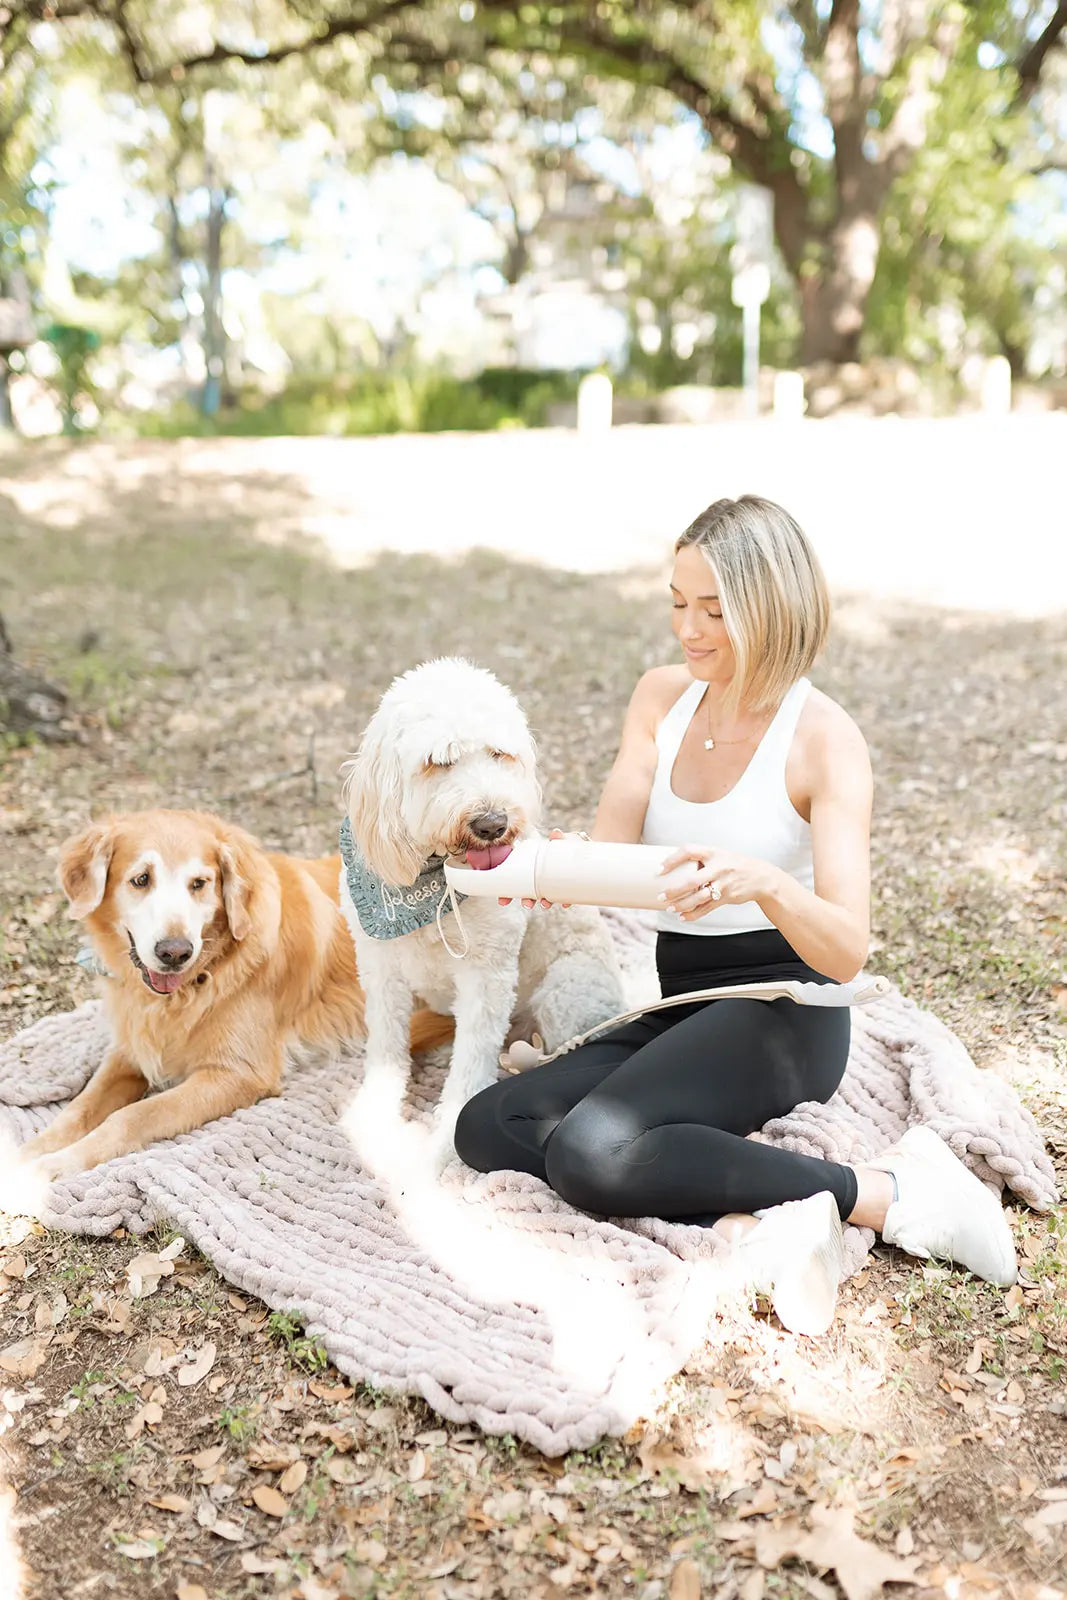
top-left (0, 414), bottom-right (1067, 616)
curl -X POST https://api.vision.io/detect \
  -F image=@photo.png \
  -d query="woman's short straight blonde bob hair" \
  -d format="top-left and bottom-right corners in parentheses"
top-left (675, 494), bottom-right (830, 710)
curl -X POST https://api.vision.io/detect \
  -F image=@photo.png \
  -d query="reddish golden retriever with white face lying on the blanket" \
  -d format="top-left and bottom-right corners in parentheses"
top-left (21, 811), bottom-right (454, 1178)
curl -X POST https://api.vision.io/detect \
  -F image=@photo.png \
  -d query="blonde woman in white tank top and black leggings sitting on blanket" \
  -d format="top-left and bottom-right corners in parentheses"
top-left (456, 494), bottom-right (1016, 1333)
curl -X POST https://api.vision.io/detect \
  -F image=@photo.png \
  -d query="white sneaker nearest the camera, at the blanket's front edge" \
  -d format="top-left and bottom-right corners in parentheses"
top-left (736, 1189), bottom-right (845, 1339)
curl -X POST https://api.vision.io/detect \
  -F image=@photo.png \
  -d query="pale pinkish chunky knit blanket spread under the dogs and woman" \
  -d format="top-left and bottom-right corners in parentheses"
top-left (0, 914), bottom-right (1056, 1454)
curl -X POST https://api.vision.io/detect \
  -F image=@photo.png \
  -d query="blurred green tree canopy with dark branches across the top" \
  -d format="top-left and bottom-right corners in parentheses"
top-left (0, 0), bottom-right (1067, 400)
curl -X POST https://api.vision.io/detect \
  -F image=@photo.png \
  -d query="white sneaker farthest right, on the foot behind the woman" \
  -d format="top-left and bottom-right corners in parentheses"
top-left (872, 1128), bottom-right (1019, 1290)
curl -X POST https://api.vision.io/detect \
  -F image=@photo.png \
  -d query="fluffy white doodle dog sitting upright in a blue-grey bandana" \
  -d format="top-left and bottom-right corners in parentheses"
top-left (341, 658), bottom-right (624, 1166)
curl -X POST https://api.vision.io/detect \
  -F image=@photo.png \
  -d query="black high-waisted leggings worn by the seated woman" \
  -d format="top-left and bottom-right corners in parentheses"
top-left (456, 930), bottom-right (856, 1226)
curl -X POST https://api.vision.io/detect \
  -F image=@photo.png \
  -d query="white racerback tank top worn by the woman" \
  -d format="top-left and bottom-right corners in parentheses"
top-left (641, 678), bottom-right (814, 936)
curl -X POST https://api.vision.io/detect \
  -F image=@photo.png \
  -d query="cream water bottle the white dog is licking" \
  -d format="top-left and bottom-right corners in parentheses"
top-left (445, 838), bottom-right (696, 910)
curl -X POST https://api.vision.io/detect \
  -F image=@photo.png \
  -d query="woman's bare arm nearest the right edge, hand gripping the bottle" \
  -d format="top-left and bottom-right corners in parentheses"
top-left (664, 706), bottom-right (872, 982)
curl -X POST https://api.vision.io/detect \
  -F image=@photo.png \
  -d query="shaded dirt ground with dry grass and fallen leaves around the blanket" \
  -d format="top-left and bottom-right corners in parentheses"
top-left (0, 446), bottom-right (1067, 1600)
